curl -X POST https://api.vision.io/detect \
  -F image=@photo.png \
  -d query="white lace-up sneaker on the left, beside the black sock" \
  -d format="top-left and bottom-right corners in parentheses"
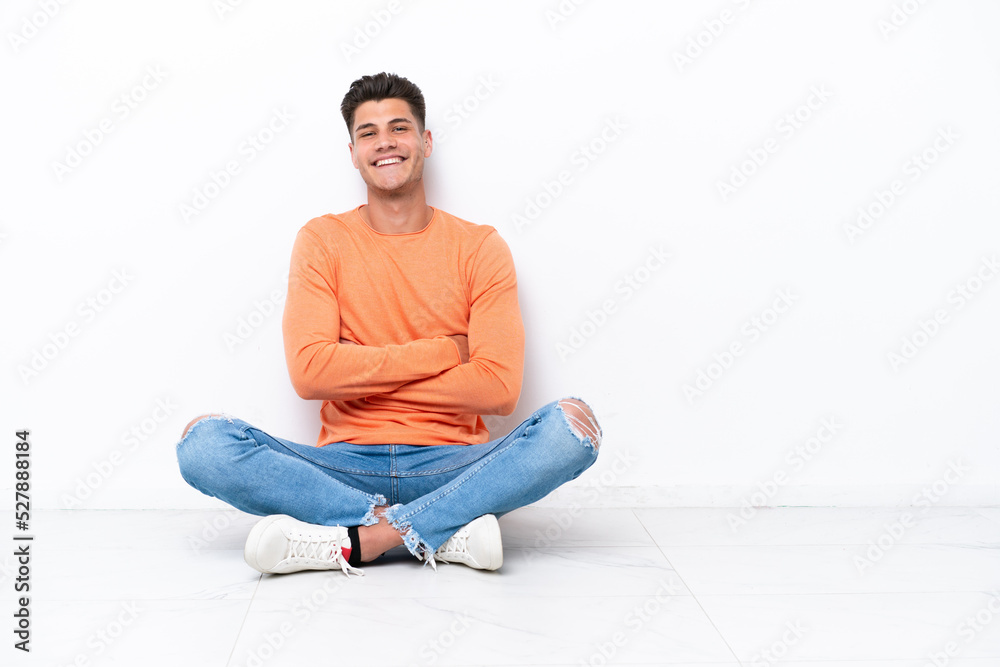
top-left (243, 514), bottom-right (364, 574)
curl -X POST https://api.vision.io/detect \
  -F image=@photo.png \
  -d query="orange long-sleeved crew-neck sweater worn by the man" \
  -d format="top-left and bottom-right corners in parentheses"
top-left (282, 206), bottom-right (524, 446)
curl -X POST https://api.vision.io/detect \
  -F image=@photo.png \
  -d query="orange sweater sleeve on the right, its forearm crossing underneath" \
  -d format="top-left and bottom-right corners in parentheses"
top-left (365, 231), bottom-right (524, 415)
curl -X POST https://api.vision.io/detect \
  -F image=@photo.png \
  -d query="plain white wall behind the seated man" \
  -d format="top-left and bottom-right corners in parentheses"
top-left (0, 0), bottom-right (1000, 508)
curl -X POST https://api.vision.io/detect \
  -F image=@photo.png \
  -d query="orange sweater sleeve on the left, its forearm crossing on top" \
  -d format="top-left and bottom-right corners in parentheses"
top-left (282, 227), bottom-right (461, 401)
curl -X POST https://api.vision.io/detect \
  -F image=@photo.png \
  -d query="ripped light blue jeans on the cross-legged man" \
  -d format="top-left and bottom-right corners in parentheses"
top-left (177, 399), bottom-right (601, 558)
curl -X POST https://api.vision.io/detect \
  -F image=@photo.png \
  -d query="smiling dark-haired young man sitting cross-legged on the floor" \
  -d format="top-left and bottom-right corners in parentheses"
top-left (177, 73), bottom-right (601, 573)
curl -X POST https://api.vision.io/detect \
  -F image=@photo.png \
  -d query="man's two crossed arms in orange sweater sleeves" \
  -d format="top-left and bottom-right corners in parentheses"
top-left (283, 230), bottom-right (524, 414)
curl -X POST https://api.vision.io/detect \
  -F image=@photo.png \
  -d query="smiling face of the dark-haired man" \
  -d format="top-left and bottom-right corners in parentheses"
top-left (350, 98), bottom-right (432, 194)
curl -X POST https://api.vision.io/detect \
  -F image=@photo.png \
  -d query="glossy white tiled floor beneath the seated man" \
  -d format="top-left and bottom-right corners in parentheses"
top-left (0, 507), bottom-right (1000, 667)
